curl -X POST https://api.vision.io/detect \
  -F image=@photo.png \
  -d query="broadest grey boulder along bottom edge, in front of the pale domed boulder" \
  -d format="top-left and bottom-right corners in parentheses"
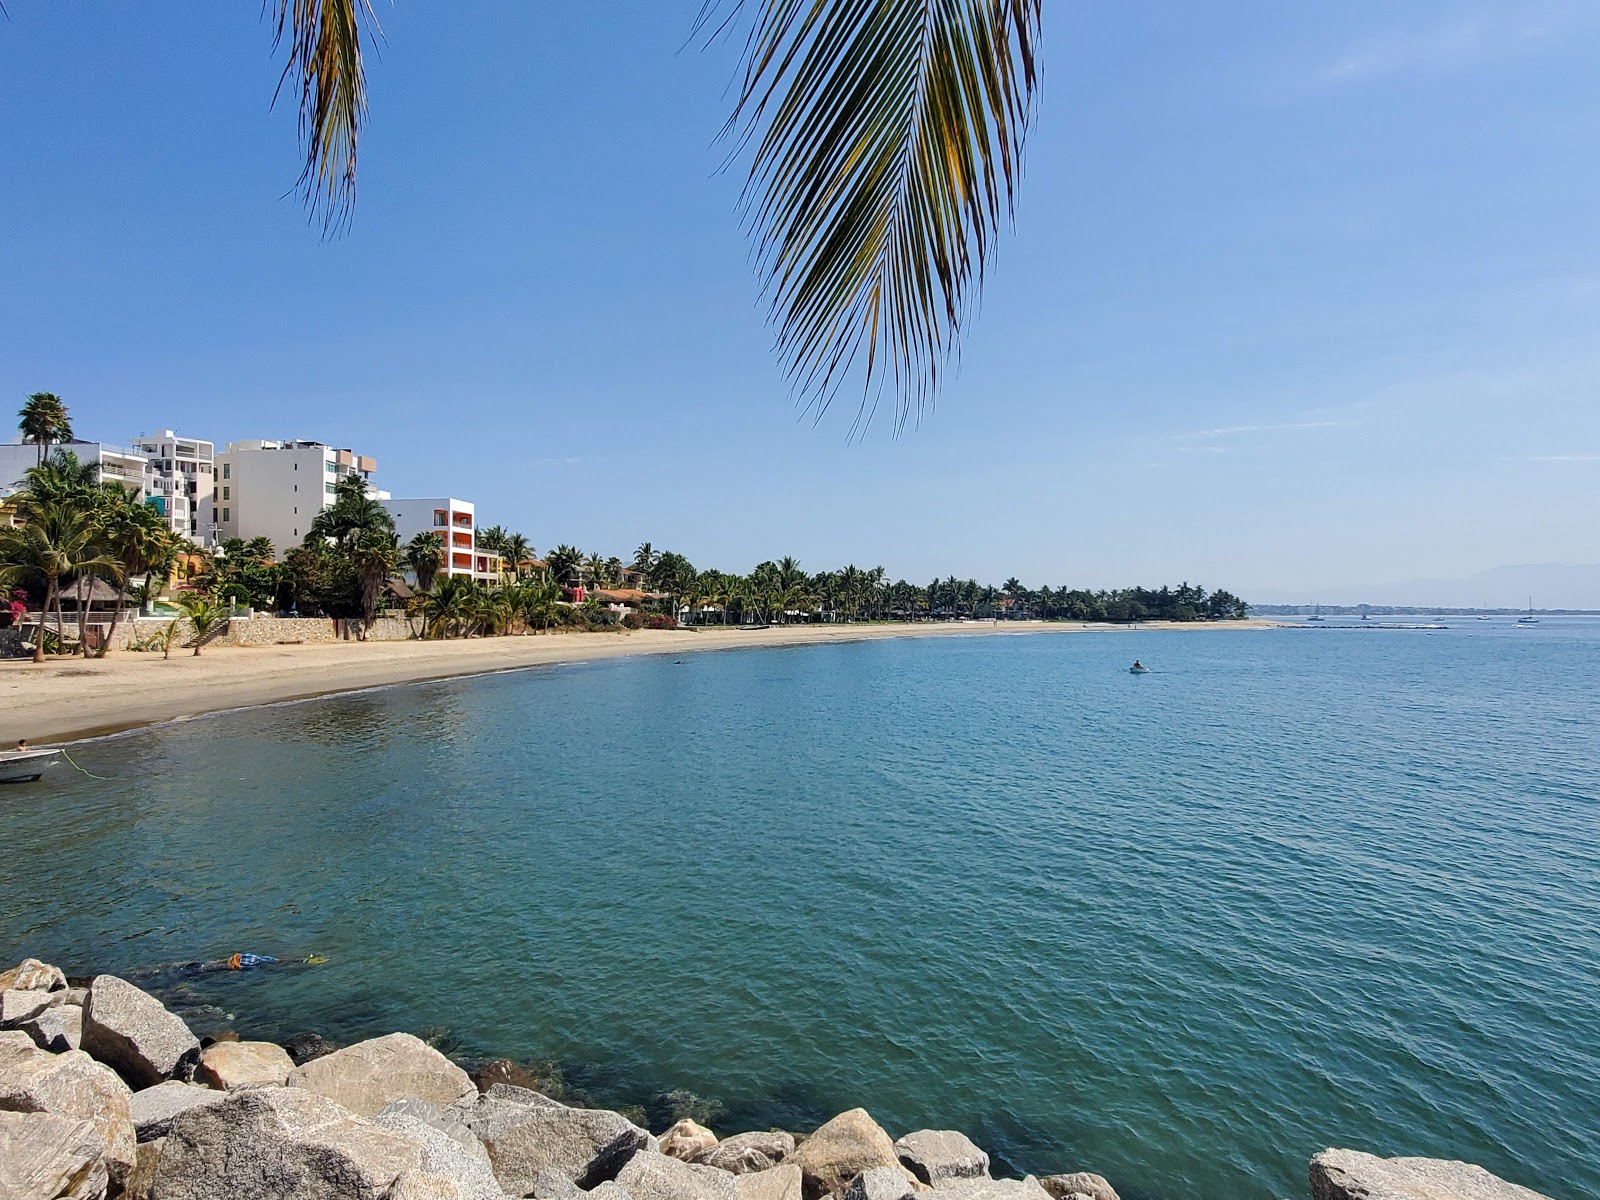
top-left (154, 1088), bottom-right (424, 1200)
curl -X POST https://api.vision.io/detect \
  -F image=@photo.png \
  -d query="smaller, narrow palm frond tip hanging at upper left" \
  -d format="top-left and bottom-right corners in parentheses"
top-left (266, 0), bottom-right (379, 234)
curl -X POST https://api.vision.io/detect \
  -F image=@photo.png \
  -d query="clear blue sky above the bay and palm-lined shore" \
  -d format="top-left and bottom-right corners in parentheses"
top-left (0, 0), bottom-right (1600, 605)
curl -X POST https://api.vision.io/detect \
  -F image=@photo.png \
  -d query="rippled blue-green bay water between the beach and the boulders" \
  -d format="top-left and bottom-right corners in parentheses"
top-left (0, 621), bottom-right (1600, 1200)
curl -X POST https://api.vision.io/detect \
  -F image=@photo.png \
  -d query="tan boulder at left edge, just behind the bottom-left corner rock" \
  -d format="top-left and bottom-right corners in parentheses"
top-left (0, 1038), bottom-right (138, 1186)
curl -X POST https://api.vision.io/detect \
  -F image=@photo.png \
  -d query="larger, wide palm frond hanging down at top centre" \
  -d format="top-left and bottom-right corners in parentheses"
top-left (720, 0), bottom-right (1042, 430)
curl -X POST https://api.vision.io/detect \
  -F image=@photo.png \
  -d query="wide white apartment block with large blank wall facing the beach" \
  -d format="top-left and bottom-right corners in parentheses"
top-left (211, 440), bottom-right (377, 560)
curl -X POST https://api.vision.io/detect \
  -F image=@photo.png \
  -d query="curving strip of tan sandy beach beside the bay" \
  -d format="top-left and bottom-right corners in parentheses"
top-left (0, 619), bottom-right (1283, 746)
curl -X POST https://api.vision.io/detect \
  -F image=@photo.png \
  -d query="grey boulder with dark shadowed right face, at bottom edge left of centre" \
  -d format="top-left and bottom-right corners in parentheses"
top-left (466, 1083), bottom-right (656, 1195)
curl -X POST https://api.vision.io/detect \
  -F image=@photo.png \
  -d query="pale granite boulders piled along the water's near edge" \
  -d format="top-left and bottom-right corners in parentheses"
top-left (0, 960), bottom-right (1568, 1200)
